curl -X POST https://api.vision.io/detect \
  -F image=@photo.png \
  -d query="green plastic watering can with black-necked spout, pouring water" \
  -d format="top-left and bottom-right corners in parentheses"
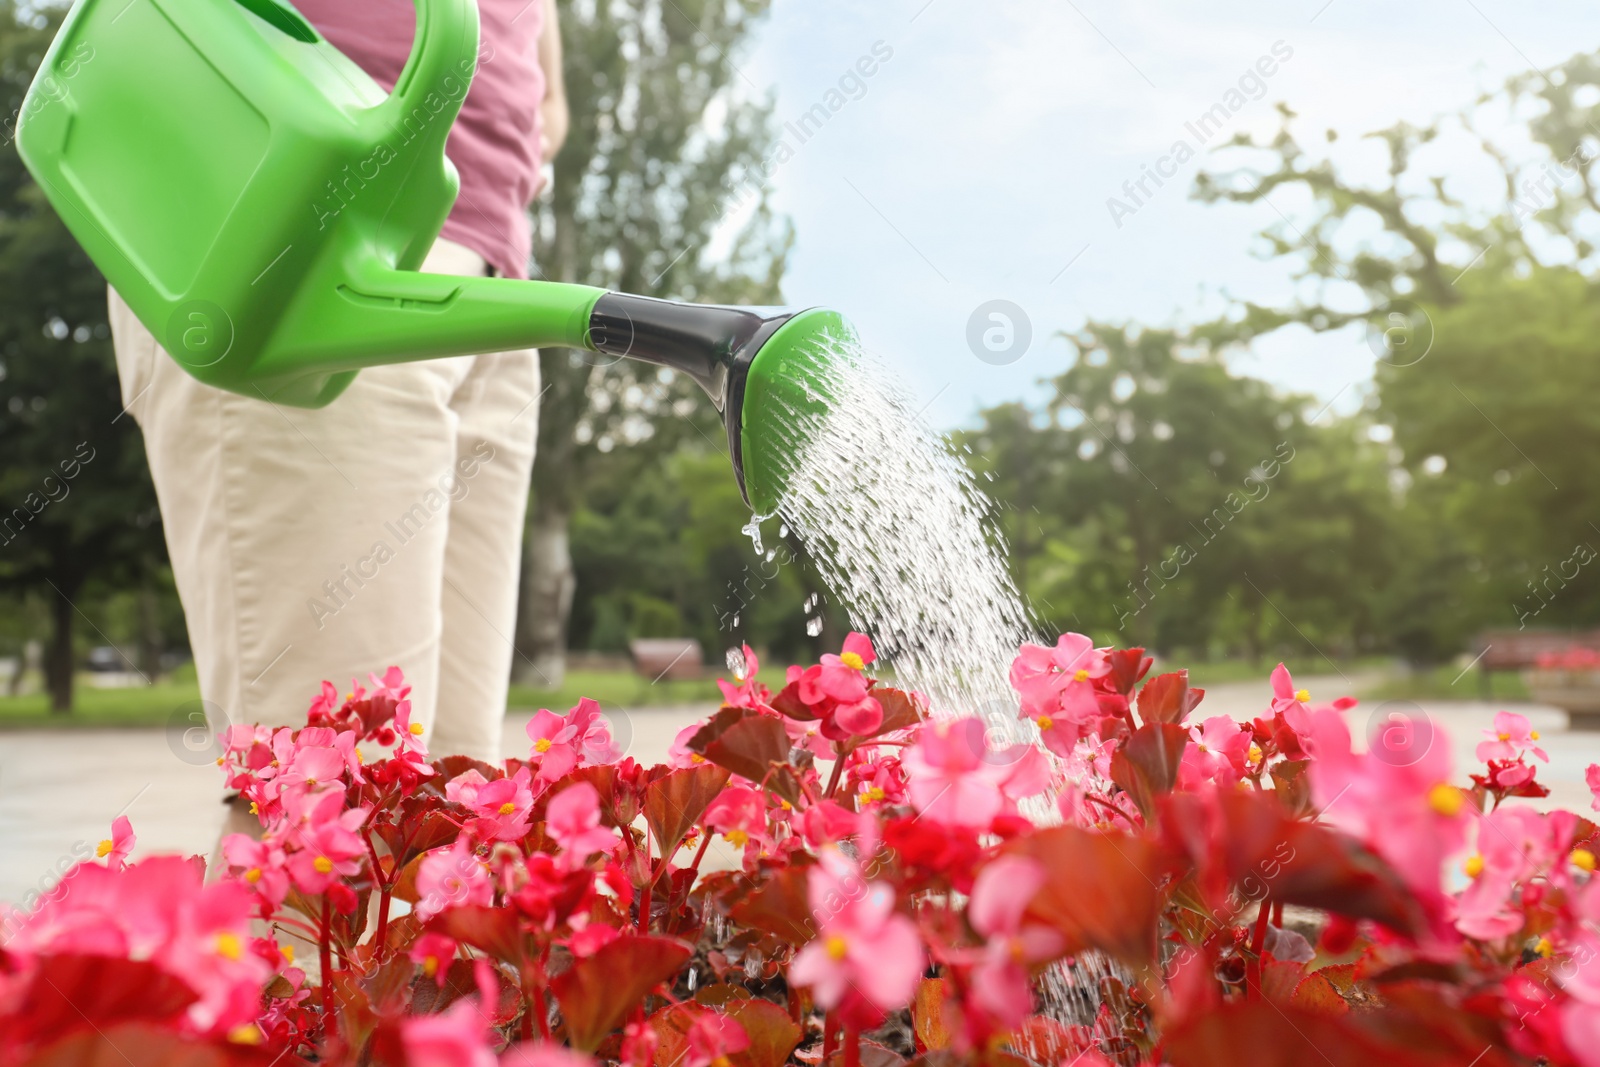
top-left (16, 0), bottom-right (851, 514)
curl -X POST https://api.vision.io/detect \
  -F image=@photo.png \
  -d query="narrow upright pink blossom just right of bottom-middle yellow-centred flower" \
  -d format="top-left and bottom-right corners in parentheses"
top-left (966, 856), bottom-right (1066, 1030)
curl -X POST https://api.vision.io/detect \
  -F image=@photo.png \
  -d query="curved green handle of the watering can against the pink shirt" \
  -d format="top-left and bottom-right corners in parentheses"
top-left (373, 0), bottom-right (478, 146)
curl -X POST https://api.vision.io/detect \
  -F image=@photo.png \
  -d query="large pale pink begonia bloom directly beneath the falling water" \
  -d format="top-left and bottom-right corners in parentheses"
top-left (901, 718), bottom-right (1050, 830)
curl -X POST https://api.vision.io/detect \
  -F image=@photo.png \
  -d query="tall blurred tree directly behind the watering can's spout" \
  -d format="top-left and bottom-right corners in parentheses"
top-left (517, 0), bottom-right (790, 685)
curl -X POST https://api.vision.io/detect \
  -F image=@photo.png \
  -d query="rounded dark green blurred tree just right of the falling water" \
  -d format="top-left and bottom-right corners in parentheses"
top-left (970, 323), bottom-right (1394, 657)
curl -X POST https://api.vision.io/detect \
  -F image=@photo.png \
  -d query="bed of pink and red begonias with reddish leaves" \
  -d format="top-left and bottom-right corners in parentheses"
top-left (0, 635), bottom-right (1600, 1067)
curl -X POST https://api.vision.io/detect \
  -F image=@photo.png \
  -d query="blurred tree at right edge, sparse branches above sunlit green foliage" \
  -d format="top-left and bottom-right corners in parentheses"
top-left (1194, 53), bottom-right (1600, 659)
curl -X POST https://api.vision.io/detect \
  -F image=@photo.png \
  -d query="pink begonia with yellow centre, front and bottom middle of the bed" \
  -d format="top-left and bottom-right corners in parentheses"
top-left (789, 849), bottom-right (928, 1011)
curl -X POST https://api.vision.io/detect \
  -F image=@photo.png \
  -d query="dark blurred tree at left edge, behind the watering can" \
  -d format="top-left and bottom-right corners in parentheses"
top-left (0, 0), bottom-right (165, 712)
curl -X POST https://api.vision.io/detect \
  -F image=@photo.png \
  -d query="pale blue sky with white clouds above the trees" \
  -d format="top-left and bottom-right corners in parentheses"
top-left (723, 0), bottom-right (1600, 427)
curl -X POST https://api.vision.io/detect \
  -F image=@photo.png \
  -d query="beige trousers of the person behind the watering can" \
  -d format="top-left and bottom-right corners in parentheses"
top-left (109, 240), bottom-right (539, 761)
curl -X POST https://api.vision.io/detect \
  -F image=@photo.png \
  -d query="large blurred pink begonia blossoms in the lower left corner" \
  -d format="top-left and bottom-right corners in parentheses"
top-left (5, 856), bottom-right (274, 1033)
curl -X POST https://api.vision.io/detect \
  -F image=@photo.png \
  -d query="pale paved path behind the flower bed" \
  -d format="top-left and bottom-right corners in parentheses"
top-left (0, 675), bottom-right (1600, 902)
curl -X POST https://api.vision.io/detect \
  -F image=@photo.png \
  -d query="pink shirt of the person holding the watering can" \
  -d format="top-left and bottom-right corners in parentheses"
top-left (294, 0), bottom-right (544, 278)
